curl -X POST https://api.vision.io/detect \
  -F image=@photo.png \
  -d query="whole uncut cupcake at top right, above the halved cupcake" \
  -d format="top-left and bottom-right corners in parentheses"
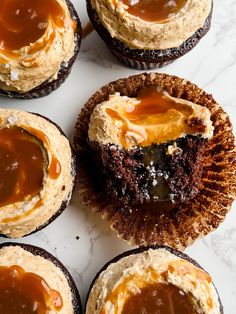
top-left (87, 0), bottom-right (212, 70)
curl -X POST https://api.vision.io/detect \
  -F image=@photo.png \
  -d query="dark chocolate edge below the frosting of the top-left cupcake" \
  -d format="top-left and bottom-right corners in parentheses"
top-left (0, 0), bottom-right (82, 99)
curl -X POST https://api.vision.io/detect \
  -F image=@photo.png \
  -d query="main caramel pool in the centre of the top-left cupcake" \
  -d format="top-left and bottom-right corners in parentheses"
top-left (0, 0), bottom-right (65, 51)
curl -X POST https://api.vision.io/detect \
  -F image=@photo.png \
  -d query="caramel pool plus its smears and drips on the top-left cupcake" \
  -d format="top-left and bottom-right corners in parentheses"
top-left (0, 0), bottom-right (74, 62)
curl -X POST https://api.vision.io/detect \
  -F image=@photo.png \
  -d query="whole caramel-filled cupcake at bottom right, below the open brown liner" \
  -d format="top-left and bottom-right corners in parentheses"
top-left (85, 247), bottom-right (223, 314)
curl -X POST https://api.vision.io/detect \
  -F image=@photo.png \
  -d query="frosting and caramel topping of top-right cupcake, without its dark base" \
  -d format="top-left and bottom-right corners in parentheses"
top-left (89, 0), bottom-right (212, 50)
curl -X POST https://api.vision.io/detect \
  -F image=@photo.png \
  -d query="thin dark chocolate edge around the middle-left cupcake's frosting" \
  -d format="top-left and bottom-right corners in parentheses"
top-left (0, 112), bottom-right (75, 239)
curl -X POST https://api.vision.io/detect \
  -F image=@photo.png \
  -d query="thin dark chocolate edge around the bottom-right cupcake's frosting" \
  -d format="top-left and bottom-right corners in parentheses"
top-left (85, 245), bottom-right (224, 314)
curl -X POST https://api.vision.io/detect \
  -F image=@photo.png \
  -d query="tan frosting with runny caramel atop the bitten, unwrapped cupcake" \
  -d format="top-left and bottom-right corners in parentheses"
top-left (88, 86), bottom-right (214, 149)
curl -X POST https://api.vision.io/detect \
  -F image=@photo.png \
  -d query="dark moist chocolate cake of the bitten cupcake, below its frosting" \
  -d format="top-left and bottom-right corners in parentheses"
top-left (89, 136), bottom-right (207, 206)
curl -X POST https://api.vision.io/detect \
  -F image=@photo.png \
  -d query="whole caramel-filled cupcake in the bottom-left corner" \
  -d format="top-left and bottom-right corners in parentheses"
top-left (0, 243), bottom-right (82, 314)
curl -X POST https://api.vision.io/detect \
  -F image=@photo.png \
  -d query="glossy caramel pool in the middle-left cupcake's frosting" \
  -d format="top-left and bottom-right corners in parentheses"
top-left (0, 127), bottom-right (45, 207)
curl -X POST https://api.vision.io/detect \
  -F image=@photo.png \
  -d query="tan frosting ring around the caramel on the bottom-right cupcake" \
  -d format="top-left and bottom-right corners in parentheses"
top-left (86, 248), bottom-right (220, 314)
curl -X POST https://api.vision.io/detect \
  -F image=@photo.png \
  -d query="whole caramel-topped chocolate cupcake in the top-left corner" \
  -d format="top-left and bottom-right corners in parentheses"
top-left (0, 0), bottom-right (81, 99)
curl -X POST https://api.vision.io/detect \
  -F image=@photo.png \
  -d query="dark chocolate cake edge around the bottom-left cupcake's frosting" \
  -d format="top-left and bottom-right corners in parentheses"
top-left (0, 242), bottom-right (83, 314)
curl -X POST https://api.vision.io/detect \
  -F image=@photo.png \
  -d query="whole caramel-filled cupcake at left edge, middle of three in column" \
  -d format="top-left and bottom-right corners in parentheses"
top-left (0, 109), bottom-right (75, 238)
